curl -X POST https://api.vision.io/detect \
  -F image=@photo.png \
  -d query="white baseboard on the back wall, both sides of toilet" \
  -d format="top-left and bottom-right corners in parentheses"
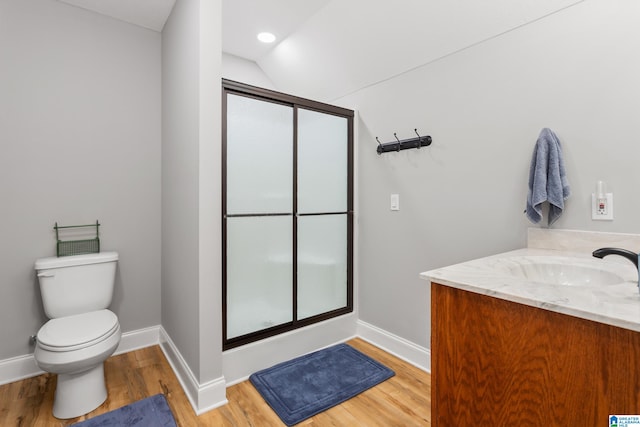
top-left (0, 326), bottom-right (160, 385)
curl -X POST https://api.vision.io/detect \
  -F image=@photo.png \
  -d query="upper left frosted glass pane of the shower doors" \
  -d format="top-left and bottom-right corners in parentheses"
top-left (226, 94), bottom-right (293, 214)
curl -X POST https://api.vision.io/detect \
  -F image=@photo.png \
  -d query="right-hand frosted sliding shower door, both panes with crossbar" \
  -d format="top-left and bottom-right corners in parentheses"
top-left (296, 108), bottom-right (349, 319)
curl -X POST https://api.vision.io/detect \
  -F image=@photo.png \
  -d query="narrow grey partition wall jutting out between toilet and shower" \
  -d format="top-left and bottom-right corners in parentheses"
top-left (162, 0), bottom-right (225, 410)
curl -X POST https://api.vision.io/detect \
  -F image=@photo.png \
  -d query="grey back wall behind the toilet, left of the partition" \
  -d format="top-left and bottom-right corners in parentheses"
top-left (0, 0), bottom-right (161, 360)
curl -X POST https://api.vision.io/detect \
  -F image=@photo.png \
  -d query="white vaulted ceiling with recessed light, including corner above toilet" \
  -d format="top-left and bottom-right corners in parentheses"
top-left (53, 0), bottom-right (585, 101)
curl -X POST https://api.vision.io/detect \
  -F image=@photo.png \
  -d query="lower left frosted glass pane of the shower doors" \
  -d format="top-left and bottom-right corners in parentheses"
top-left (226, 215), bottom-right (293, 339)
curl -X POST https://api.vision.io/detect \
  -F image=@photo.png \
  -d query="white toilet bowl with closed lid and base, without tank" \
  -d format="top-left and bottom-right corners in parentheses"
top-left (34, 310), bottom-right (121, 419)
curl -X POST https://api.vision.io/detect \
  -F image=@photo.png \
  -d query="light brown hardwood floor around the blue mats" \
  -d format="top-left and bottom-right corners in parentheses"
top-left (0, 338), bottom-right (431, 427)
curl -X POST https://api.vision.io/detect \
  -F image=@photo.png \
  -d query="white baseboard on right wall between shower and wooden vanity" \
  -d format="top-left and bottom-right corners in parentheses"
top-left (357, 320), bottom-right (431, 372)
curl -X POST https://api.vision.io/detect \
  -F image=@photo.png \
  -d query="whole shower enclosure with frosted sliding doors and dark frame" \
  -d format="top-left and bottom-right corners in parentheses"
top-left (222, 80), bottom-right (353, 349)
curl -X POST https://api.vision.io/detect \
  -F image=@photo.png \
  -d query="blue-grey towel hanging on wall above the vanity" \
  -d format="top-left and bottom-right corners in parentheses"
top-left (525, 128), bottom-right (571, 225)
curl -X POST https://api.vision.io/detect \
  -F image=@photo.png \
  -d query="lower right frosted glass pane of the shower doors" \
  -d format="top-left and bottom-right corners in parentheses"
top-left (298, 214), bottom-right (347, 319)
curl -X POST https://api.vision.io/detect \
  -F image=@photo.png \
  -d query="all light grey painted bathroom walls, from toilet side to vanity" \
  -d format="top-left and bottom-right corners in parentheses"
top-left (0, 0), bottom-right (640, 392)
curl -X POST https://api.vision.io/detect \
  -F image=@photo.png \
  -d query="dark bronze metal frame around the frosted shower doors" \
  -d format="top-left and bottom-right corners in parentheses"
top-left (221, 79), bottom-right (354, 350)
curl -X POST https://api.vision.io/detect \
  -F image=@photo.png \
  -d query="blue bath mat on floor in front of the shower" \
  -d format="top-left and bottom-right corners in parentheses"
top-left (249, 344), bottom-right (395, 426)
